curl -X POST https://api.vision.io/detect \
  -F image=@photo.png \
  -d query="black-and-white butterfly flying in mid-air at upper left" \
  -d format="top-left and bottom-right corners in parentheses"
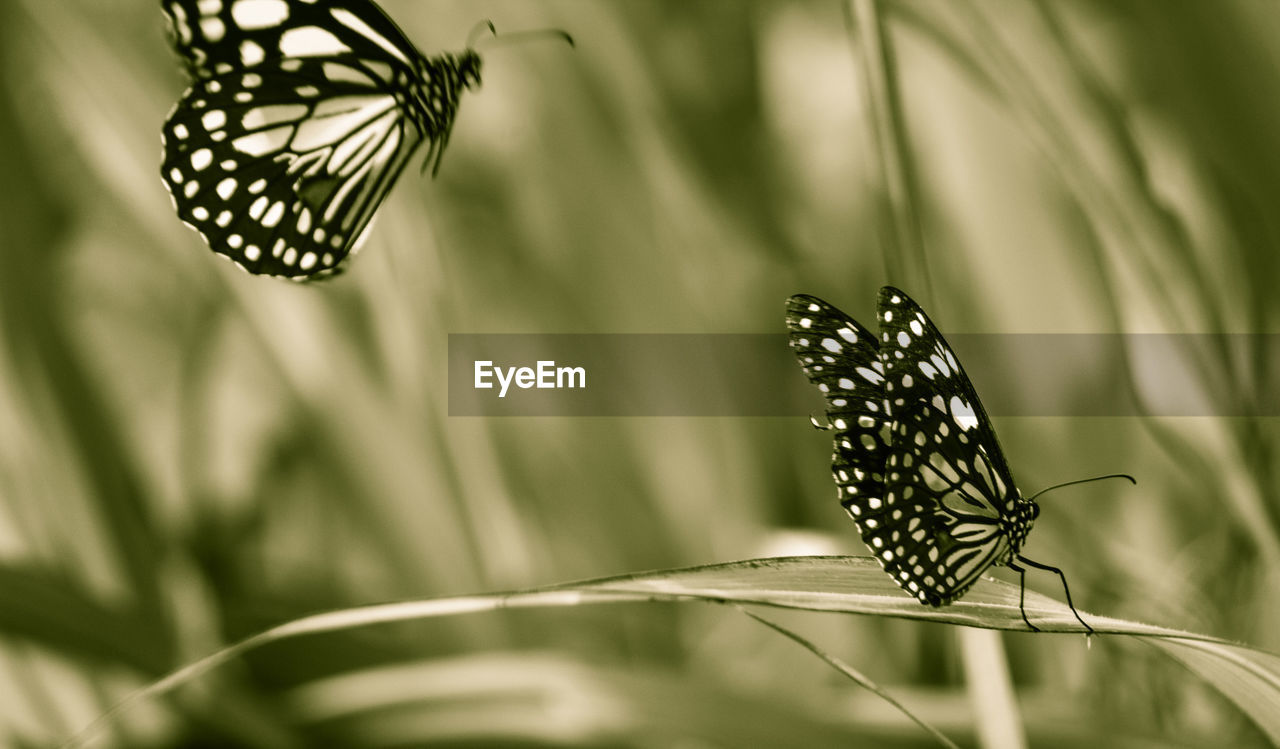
top-left (161, 0), bottom-right (573, 280)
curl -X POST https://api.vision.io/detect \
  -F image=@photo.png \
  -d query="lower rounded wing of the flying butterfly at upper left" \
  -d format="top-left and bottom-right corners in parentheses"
top-left (161, 58), bottom-right (422, 279)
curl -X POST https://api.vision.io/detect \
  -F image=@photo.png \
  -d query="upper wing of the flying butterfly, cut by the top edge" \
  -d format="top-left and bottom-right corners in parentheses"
top-left (161, 0), bottom-right (421, 78)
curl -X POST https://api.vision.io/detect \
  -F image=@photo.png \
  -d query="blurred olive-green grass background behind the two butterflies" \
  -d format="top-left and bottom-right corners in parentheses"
top-left (0, 0), bottom-right (1280, 748)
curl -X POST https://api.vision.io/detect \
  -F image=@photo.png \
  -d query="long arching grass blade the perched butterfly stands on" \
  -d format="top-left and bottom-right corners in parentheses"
top-left (70, 557), bottom-right (1280, 745)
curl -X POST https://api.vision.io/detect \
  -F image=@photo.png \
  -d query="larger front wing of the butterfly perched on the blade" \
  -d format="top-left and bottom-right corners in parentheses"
top-left (872, 287), bottom-right (1029, 606)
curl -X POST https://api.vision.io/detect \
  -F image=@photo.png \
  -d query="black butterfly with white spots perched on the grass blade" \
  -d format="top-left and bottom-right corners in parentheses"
top-left (786, 287), bottom-right (1133, 632)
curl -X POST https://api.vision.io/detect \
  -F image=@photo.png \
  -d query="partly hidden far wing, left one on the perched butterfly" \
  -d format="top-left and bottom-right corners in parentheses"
top-left (787, 294), bottom-right (888, 532)
